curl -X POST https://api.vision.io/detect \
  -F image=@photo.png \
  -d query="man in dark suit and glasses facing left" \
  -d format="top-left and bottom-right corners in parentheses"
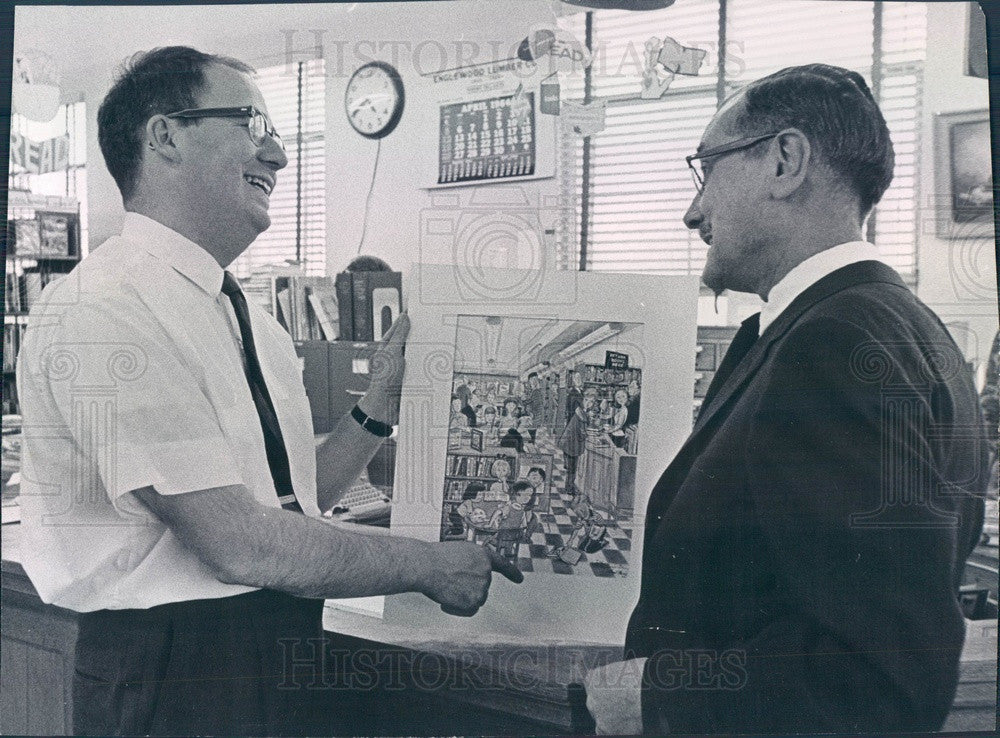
top-left (586, 64), bottom-right (988, 735)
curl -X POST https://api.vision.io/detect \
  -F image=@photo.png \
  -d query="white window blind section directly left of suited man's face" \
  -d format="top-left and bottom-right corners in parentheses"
top-left (564, 0), bottom-right (719, 274)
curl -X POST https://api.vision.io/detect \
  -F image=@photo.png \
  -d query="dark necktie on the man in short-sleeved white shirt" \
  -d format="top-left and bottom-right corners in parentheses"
top-left (222, 272), bottom-right (302, 512)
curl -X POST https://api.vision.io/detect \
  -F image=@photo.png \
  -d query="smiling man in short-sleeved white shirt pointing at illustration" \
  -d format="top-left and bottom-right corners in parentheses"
top-left (18, 47), bottom-right (520, 735)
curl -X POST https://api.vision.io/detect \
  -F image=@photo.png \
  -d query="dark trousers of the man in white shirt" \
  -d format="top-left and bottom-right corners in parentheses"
top-left (73, 590), bottom-right (323, 735)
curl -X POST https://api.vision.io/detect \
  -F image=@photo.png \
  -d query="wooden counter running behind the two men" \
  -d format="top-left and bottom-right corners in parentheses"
top-left (0, 525), bottom-right (997, 735)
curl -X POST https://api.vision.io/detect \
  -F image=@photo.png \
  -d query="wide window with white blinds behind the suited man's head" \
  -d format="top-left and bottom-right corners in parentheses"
top-left (560, 0), bottom-right (927, 283)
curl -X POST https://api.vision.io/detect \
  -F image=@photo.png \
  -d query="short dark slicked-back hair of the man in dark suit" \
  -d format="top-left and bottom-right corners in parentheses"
top-left (734, 64), bottom-right (895, 218)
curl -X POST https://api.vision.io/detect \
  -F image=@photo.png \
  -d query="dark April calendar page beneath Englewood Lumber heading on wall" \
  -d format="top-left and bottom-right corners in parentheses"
top-left (437, 91), bottom-right (537, 185)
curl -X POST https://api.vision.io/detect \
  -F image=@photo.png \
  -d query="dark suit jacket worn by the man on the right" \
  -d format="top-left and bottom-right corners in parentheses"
top-left (625, 261), bottom-right (987, 735)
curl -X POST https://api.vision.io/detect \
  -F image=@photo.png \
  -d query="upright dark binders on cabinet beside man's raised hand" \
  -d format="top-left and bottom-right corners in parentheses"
top-left (336, 272), bottom-right (403, 341)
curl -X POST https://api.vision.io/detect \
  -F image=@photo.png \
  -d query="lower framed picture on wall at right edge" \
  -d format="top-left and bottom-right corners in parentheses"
top-left (934, 110), bottom-right (993, 238)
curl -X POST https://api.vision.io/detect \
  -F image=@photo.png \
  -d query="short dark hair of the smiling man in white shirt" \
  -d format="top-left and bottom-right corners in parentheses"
top-left (97, 46), bottom-right (254, 203)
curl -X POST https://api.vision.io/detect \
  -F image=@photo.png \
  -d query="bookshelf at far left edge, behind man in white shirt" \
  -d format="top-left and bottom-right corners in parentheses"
top-left (2, 189), bottom-right (80, 414)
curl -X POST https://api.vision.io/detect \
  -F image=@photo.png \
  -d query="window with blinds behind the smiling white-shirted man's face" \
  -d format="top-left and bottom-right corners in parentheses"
top-left (231, 59), bottom-right (326, 277)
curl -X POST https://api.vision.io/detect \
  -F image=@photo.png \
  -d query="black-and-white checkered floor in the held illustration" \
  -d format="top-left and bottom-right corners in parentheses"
top-left (517, 429), bottom-right (632, 577)
